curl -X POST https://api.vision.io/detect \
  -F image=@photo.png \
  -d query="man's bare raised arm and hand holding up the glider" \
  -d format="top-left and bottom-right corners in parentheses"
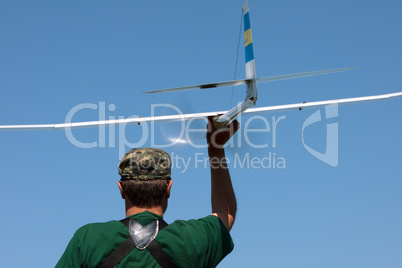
top-left (207, 118), bottom-right (239, 231)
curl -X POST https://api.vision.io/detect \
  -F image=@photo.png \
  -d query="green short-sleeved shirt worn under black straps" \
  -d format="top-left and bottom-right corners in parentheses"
top-left (56, 211), bottom-right (234, 267)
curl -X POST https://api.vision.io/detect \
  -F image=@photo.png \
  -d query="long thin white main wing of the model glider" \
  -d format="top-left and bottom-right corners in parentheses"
top-left (0, 92), bottom-right (402, 131)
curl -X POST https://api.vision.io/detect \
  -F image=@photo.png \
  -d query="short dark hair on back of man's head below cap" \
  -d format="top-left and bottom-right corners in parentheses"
top-left (121, 180), bottom-right (170, 208)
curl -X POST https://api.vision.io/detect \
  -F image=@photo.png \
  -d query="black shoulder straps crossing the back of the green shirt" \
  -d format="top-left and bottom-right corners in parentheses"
top-left (98, 218), bottom-right (175, 268)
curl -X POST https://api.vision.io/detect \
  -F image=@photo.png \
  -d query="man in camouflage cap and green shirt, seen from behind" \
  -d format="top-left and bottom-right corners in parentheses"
top-left (56, 118), bottom-right (239, 267)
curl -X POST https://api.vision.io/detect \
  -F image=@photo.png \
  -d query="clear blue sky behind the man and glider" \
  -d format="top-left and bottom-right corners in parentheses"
top-left (0, 0), bottom-right (402, 267)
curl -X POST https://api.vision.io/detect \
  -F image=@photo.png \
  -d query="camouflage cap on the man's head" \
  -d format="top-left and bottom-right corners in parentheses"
top-left (119, 148), bottom-right (172, 181)
